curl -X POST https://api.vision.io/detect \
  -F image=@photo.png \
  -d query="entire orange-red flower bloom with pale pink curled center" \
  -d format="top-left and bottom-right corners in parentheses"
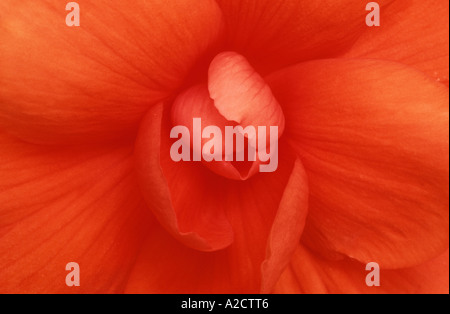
top-left (0, 0), bottom-right (449, 293)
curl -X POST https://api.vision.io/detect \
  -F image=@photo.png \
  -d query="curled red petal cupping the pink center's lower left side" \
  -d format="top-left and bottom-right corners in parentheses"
top-left (135, 105), bottom-right (233, 251)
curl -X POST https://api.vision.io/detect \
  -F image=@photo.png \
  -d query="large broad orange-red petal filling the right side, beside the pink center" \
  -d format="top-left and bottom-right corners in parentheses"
top-left (268, 60), bottom-right (449, 268)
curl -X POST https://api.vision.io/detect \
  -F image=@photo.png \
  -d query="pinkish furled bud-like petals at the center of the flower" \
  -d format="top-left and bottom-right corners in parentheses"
top-left (171, 52), bottom-right (285, 180)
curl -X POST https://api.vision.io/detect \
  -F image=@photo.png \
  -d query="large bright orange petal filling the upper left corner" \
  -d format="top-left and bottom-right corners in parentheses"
top-left (0, 0), bottom-right (222, 143)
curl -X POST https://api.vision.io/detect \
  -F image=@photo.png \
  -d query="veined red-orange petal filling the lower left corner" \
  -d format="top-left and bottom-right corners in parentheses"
top-left (0, 134), bottom-right (150, 293)
